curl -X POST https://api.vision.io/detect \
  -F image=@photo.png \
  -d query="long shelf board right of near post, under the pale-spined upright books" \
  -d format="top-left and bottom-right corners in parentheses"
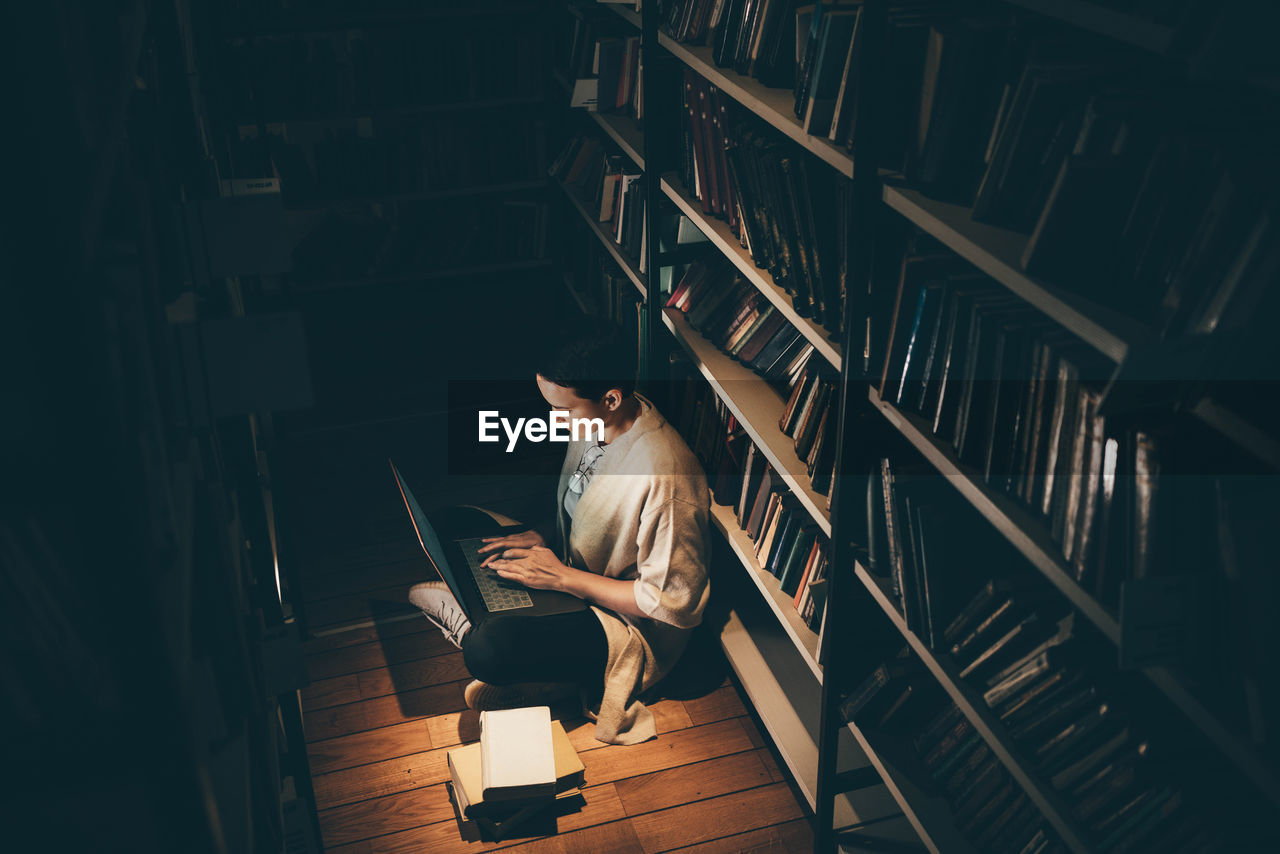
top-left (868, 389), bottom-right (1280, 805)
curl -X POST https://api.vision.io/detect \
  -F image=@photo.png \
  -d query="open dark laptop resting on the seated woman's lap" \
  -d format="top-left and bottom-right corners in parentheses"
top-left (388, 461), bottom-right (586, 625)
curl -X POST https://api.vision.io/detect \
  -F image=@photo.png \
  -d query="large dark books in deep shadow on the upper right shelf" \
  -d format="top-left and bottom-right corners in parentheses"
top-left (884, 13), bottom-right (1280, 337)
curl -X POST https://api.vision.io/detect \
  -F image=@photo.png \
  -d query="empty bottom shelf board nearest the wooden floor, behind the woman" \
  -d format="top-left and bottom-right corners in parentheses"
top-left (719, 611), bottom-right (897, 826)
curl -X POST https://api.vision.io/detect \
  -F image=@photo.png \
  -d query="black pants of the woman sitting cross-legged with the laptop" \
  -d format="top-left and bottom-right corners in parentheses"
top-left (431, 507), bottom-right (609, 690)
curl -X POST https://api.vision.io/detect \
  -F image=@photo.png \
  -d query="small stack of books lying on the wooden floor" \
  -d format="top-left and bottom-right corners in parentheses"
top-left (447, 705), bottom-right (586, 841)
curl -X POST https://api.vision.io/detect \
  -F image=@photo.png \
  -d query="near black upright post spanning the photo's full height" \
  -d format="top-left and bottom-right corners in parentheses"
top-left (815, 0), bottom-right (888, 853)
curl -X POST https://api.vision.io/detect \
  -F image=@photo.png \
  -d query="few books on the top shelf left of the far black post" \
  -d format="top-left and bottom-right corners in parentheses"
top-left (564, 5), bottom-right (644, 119)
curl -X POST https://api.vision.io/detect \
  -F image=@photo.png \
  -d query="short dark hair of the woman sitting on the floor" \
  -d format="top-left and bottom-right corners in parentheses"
top-left (536, 318), bottom-right (636, 401)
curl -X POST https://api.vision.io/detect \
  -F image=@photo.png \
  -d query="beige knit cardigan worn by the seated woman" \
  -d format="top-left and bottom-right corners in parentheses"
top-left (556, 394), bottom-right (710, 744)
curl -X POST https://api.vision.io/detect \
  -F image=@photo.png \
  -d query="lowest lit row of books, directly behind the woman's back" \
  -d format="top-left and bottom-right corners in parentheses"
top-left (673, 376), bottom-right (829, 631)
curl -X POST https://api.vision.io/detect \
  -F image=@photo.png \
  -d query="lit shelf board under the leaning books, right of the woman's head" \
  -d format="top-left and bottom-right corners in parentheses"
top-left (662, 309), bottom-right (831, 538)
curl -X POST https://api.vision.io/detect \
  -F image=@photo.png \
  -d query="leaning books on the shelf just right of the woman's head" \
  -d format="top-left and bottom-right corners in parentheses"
top-left (667, 252), bottom-right (814, 382)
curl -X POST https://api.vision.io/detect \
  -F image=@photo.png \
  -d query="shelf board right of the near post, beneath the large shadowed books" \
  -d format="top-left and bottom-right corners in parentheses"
top-left (883, 183), bottom-right (1151, 364)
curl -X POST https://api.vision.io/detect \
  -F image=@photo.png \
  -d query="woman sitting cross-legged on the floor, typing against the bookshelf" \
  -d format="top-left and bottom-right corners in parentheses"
top-left (410, 324), bottom-right (710, 744)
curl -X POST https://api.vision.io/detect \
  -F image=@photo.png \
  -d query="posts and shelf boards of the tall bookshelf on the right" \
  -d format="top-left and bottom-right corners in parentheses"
top-left (564, 0), bottom-right (1280, 853)
